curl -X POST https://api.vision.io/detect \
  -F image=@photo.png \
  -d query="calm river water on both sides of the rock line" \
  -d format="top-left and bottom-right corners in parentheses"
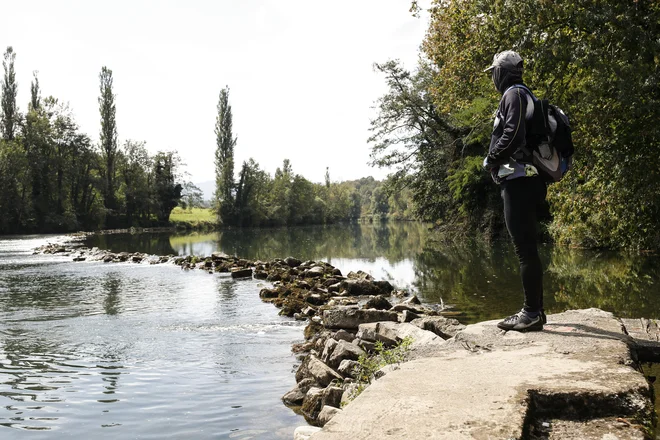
top-left (0, 223), bottom-right (660, 440)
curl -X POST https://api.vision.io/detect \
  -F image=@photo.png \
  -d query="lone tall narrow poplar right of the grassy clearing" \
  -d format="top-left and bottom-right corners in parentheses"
top-left (215, 87), bottom-right (236, 223)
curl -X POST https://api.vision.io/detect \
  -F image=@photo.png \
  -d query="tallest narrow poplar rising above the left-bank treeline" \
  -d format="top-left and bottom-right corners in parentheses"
top-left (99, 66), bottom-right (117, 214)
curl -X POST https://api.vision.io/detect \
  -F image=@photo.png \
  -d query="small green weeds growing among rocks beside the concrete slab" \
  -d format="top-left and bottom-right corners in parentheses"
top-left (349, 336), bottom-right (413, 400)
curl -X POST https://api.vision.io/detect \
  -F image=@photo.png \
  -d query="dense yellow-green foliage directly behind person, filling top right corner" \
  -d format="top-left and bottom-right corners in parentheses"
top-left (423, 0), bottom-right (660, 249)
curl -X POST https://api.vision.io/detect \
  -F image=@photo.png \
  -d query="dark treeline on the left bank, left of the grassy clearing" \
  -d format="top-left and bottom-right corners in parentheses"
top-left (0, 47), bottom-right (182, 233)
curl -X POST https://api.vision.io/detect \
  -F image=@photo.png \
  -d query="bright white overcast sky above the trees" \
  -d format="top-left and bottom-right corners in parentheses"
top-left (0, 0), bottom-right (428, 183)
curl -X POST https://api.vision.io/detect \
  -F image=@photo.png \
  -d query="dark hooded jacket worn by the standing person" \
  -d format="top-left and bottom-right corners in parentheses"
top-left (486, 67), bottom-right (534, 166)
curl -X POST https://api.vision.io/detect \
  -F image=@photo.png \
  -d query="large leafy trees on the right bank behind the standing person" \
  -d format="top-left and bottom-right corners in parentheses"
top-left (371, 0), bottom-right (660, 249)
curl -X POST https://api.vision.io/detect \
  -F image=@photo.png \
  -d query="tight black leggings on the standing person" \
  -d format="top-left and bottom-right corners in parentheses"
top-left (502, 177), bottom-right (547, 312)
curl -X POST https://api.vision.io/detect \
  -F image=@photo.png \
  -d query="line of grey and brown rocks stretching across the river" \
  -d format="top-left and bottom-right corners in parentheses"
top-left (35, 244), bottom-right (464, 432)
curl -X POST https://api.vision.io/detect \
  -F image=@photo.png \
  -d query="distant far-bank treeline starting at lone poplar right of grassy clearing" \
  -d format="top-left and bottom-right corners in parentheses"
top-left (213, 88), bottom-right (413, 226)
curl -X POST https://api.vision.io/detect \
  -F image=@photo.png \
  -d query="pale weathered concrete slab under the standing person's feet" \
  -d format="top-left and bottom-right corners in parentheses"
top-left (311, 309), bottom-right (653, 440)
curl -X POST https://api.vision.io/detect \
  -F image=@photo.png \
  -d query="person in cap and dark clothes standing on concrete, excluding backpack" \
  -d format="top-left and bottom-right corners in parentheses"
top-left (483, 50), bottom-right (546, 331)
